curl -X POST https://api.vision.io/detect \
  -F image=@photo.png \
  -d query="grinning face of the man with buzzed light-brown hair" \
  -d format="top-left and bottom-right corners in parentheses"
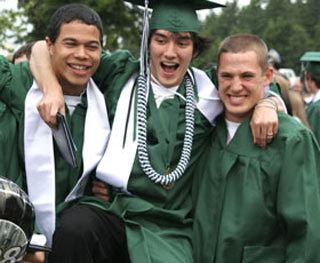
top-left (217, 51), bottom-right (273, 122)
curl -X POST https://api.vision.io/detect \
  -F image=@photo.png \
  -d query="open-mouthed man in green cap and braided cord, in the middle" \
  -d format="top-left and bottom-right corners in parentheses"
top-left (28, 1), bottom-right (276, 263)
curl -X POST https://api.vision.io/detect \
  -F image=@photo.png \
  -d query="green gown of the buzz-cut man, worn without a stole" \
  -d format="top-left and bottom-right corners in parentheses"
top-left (193, 113), bottom-right (320, 263)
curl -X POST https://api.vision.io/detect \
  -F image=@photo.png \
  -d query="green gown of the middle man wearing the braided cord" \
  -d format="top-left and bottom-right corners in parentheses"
top-left (72, 52), bottom-right (215, 263)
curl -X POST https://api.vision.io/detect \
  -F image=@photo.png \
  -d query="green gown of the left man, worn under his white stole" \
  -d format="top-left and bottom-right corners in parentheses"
top-left (0, 57), bottom-right (91, 221)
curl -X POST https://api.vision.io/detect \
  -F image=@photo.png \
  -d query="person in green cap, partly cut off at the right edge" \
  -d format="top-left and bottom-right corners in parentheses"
top-left (302, 52), bottom-right (320, 142)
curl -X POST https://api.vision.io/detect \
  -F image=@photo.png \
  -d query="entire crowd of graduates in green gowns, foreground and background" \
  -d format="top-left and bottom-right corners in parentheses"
top-left (0, 0), bottom-right (320, 263)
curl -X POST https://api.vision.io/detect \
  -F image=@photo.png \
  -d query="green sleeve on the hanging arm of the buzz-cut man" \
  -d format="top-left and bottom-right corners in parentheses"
top-left (277, 124), bottom-right (320, 263)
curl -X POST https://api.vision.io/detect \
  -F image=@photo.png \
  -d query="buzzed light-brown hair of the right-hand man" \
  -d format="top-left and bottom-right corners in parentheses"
top-left (218, 34), bottom-right (268, 71)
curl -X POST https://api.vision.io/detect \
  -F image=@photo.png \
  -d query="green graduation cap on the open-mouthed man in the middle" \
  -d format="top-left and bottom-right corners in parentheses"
top-left (126, 0), bottom-right (224, 33)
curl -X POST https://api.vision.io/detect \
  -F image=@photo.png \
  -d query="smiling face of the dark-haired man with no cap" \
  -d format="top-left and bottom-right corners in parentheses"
top-left (46, 21), bottom-right (101, 95)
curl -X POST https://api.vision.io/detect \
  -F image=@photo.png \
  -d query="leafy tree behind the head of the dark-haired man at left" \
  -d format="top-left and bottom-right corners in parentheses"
top-left (19, 0), bottom-right (142, 53)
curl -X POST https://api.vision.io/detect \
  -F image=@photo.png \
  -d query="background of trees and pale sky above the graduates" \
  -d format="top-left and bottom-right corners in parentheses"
top-left (0, 0), bottom-right (320, 74)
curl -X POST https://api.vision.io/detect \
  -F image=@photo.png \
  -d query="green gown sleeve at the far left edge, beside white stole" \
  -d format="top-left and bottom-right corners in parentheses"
top-left (0, 57), bottom-right (32, 189)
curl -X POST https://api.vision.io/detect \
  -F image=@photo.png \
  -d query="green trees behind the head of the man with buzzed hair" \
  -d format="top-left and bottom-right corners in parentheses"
top-left (194, 0), bottom-right (320, 73)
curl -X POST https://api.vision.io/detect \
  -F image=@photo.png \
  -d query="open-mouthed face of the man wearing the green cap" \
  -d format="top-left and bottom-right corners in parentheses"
top-left (149, 30), bottom-right (194, 87)
